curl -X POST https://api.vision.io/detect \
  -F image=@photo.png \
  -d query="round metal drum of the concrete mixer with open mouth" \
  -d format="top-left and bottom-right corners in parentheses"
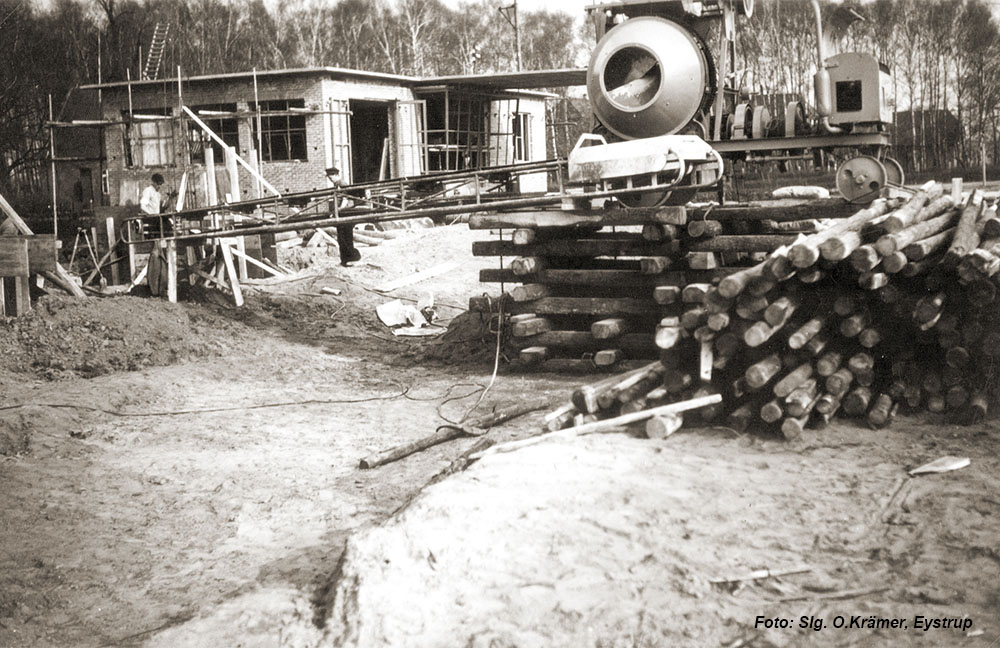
top-left (587, 16), bottom-right (715, 139)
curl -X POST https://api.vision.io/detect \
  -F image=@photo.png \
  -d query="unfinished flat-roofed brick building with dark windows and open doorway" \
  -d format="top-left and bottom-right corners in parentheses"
top-left (84, 68), bottom-right (551, 210)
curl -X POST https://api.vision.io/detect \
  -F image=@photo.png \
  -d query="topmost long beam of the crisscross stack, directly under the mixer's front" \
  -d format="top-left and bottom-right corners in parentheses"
top-left (469, 206), bottom-right (687, 230)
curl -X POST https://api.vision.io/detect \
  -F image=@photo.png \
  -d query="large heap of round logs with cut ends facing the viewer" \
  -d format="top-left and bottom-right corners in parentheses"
top-left (546, 183), bottom-right (1000, 438)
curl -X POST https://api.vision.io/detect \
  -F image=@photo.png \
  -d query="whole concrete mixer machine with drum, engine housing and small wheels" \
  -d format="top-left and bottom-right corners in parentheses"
top-left (569, 0), bottom-right (903, 206)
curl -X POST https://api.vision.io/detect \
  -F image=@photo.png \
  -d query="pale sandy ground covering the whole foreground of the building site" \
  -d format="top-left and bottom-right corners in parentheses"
top-left (0, 226), bottom-right (1000, 648)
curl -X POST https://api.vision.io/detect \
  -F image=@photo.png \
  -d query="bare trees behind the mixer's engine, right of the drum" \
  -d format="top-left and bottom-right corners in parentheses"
top-left (740, 0), bottom-right (1000, 171)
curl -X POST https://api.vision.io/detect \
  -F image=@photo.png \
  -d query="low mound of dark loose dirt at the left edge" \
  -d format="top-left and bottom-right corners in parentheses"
top-left (0, 296), bottom-right (254, 384)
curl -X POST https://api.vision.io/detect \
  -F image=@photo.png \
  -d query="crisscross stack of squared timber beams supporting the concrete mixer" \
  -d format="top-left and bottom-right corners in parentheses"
top-left (469, 200), bottom-right (856, 370)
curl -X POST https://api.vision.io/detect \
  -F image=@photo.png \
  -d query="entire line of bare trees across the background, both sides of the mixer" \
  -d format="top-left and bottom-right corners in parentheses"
top-left (0, 0), bottom-right (1000, 204)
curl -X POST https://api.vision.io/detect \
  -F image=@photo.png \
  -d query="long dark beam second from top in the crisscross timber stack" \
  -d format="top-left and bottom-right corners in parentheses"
top-left (472, 234), bottom-right (678, 257)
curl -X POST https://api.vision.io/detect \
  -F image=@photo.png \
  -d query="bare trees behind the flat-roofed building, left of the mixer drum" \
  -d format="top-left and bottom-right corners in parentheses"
top-left (0, 0), bottom-right (587, 200)
